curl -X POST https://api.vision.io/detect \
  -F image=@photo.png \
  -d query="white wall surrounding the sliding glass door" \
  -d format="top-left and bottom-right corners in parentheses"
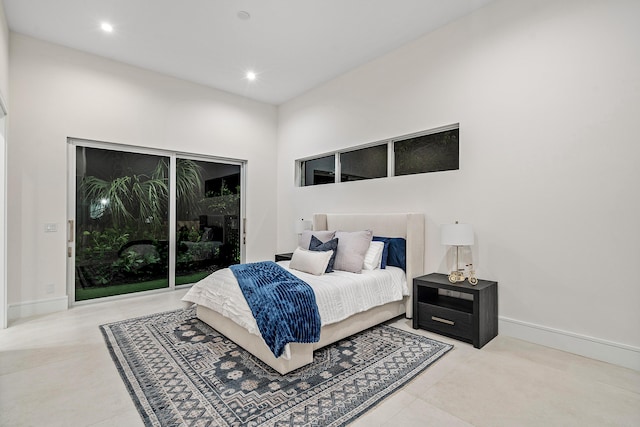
top-left (8, 33), bottom-right (276, 309)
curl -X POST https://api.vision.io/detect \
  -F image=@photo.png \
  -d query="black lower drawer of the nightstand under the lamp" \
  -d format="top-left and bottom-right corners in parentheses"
top-left (418, 303), bottom-right (473, 340)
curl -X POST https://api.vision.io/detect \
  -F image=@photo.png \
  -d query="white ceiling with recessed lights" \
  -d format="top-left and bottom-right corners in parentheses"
top-left (3, 0), bottom-right (491, 105)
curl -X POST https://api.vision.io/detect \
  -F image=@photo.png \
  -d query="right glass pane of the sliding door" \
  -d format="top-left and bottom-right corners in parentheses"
top-left (176, 159), bottom-right (240, 285)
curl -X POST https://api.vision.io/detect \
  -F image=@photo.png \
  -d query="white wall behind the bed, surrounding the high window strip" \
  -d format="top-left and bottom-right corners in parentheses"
top-left (278, 0), bottom-right (640, 369)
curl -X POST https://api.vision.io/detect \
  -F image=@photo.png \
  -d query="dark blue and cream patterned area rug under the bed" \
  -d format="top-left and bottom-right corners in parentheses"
top-left (100, 308), bottom-right (452, 426)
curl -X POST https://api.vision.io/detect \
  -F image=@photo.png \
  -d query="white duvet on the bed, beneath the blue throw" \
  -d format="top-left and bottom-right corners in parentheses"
top-left (182, 261), bottom-right (409, 358)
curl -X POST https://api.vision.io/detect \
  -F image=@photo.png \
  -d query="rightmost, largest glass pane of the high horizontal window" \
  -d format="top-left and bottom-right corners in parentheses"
top-left (394, 129), bottom-right (460, 176)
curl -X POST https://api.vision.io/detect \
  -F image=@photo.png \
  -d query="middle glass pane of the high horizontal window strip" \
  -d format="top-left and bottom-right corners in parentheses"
top-left (340, 144), bottom-right (387, 182)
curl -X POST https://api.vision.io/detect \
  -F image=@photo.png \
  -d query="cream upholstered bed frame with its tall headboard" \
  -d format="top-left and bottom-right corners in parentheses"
top-left (185, 213), bottom-right (425, 374)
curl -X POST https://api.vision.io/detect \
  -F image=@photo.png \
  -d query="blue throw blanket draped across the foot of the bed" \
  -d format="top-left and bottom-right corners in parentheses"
top-left (229, 261), bottom-right (320, 357)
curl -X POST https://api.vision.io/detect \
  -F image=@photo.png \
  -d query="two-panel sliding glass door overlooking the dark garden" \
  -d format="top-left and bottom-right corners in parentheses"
top-left (67, 140), bottom-right (242, 302)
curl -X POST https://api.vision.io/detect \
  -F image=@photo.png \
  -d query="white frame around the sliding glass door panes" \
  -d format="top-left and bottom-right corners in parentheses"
top-left (66, 137), bottom-right (247, 307)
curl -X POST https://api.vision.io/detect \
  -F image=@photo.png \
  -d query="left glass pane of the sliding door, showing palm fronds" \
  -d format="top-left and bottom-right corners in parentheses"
top-left (75, 146), bottom-right (169, 301)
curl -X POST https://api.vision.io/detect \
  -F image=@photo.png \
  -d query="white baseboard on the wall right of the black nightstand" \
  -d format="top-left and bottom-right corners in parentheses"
top-left (498, 316), bottom-right (640, 371)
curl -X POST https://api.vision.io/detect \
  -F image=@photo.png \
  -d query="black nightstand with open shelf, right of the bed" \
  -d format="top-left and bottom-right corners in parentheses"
top-left (413, 273), bottom-right (498, 348)
